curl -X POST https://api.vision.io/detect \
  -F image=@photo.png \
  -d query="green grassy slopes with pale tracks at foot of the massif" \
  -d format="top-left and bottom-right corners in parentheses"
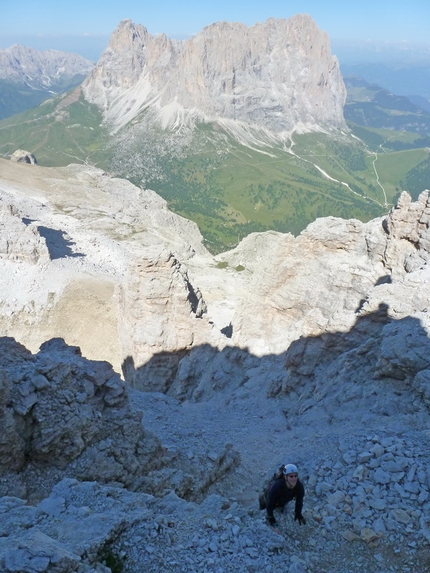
top-left (0, 89), bottom-right (430, 252)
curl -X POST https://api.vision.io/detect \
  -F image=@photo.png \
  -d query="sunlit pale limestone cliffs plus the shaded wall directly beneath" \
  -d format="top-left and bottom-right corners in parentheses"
top-left (0, 160), bottom-right (430, 399)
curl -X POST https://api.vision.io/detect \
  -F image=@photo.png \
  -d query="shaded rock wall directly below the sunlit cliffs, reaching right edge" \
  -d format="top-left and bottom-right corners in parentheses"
top-left (123, 304), bottom-right (430, 414)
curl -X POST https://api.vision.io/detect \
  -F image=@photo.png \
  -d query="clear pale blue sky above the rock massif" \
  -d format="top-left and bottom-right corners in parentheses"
top-left (0, 0), bottom-right (430, 60)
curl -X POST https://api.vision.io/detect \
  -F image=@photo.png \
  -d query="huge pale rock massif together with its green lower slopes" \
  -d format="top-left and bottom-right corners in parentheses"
top-left (0, 15), bottom-right (430, 252)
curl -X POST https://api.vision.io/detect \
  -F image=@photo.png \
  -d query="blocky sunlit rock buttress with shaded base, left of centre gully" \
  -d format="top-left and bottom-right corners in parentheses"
top-left (120, 250), bottom-right (223, 392)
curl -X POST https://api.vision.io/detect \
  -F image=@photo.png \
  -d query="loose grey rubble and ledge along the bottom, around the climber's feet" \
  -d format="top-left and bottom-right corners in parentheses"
top-left (0, 428), bottom-right (429, 573)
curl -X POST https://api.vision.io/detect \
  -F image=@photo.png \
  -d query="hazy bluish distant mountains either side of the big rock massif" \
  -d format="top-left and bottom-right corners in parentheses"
top-left (0, 34), bottom-right (430, 123)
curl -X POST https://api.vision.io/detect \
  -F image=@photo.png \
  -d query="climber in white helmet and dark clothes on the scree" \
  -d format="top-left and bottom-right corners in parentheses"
top-left (260, 464), bottom-right (306, 526)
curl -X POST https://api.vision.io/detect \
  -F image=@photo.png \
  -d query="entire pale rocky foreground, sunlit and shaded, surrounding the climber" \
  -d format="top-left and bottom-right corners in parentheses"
top-left (0, 161), bottom-right (430, 573)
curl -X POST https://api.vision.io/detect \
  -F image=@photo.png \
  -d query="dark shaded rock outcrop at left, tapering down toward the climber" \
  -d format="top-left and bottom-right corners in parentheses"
top-left (0, 337), bottom-right (239, 500)
